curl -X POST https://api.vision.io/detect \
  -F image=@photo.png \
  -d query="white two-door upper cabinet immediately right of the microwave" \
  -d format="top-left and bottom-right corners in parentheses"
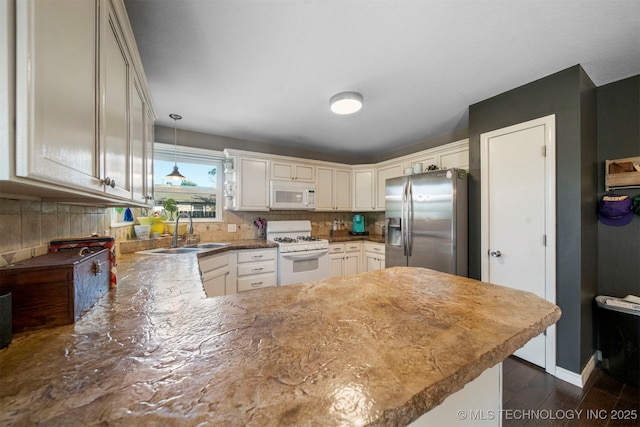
top-left (316, 166), bottom-right (351, 211)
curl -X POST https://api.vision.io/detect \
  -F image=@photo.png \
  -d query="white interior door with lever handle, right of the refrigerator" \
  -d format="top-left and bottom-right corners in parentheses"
top-left (480, 116), bottom-right (555, 373)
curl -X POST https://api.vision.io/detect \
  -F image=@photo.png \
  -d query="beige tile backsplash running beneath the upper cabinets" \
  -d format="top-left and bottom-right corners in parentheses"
top-left (0, 198), bottom-right (384, 267)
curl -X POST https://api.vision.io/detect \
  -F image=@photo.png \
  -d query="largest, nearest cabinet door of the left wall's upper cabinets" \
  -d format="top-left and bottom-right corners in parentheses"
top-left (14, 0), bottom-right (102, 192)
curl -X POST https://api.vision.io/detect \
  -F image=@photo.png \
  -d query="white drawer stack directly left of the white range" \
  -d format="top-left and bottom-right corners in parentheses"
top-left (237, 248), bottom-right (278, 292)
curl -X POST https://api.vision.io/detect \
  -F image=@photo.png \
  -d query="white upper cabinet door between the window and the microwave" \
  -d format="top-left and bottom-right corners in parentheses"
top-left (236, 157), bottom-right (269, 211)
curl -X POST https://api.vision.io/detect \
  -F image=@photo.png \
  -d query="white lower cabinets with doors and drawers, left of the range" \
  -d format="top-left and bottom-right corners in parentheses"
top-left (198, 248), bottom-right (278, 297)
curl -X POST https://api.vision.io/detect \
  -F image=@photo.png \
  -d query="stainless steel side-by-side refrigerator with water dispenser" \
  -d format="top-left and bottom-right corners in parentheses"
top-left (385, 169), bottom-right (468, 277)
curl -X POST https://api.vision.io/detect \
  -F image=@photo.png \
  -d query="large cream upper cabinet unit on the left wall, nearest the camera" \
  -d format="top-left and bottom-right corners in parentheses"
top-left (0, 0), bottom-right (155, 205)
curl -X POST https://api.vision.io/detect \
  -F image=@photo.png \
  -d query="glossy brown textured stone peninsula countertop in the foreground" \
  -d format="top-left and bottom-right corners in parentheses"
top-left (0, 254), bottom-right (560, 426)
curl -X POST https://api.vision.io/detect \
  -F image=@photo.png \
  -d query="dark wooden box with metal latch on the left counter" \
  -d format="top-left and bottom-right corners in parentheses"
top-left (0, 248), bottom-right (110, 333)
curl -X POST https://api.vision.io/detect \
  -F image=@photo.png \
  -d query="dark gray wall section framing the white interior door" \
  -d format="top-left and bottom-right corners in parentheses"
top-left (469, 66), bottom-right (598, 373)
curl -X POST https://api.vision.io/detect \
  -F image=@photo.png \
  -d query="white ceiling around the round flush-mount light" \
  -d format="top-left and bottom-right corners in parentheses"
top-left (125, 0), bottom-right (640, 156)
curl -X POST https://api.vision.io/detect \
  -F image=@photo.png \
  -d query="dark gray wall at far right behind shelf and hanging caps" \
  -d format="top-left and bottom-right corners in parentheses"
top-left (598, 75), bottom-right (640, 297)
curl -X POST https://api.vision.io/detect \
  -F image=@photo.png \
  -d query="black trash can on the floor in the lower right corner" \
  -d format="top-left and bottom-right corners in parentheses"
top-left (596, 296), bottom-right (640, 387)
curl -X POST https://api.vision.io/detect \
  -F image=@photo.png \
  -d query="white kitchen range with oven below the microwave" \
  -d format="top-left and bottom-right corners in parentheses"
top-left (267, 220), bottom-right (330, 286)
